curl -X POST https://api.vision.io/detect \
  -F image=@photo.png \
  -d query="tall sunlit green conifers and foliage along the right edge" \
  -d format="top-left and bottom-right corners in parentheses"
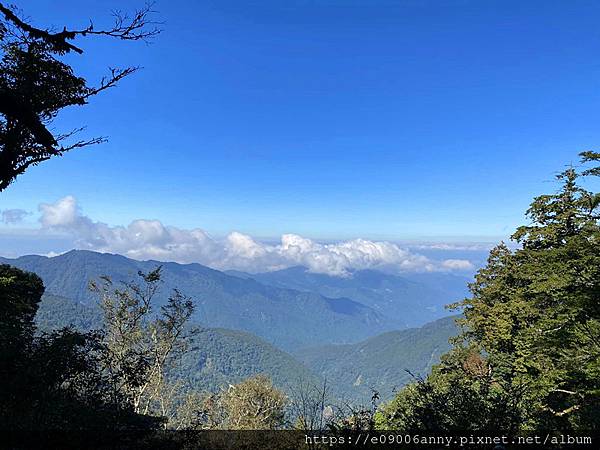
top-left (378, 152), bottom-right (600, 431)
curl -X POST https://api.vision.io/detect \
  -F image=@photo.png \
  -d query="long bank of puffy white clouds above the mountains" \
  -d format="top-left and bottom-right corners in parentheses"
top-left (34, 196), bottom-right (473, 276)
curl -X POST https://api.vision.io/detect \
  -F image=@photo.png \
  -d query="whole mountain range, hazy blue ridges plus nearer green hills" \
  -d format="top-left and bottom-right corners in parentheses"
top-left (0, 250), bottom-right (466, 402)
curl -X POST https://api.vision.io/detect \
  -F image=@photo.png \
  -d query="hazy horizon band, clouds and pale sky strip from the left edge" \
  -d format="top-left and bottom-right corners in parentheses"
top-left (0, 196), bottom-right (497, 275)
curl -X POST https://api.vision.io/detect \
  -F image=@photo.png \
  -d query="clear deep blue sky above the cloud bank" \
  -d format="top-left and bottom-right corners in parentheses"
top-left (0, 0), bottom-right (600, 241)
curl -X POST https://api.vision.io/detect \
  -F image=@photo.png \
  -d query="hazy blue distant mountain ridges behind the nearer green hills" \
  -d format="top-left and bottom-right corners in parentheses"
top-left (0, 250), bottom-right (466, 351)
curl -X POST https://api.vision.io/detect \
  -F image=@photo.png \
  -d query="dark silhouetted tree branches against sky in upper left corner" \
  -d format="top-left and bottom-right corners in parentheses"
top-left (0, 3), bottom-right (160, 192)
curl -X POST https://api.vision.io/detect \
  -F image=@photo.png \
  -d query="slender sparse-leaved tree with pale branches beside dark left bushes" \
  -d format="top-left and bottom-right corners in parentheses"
top-left (91, 266), bottom-right (194, 426)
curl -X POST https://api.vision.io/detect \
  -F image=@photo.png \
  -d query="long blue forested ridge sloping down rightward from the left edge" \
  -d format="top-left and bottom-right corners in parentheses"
top-left (0, 251), bottom-right (395, 350)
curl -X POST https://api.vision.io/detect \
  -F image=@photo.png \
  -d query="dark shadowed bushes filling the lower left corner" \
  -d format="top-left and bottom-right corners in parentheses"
top-left (0, 265), bottom-right (160, 430)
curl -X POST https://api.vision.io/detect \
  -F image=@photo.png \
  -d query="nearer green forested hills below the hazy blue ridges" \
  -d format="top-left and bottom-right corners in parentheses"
top-left (36, 284), bottom-right (458, 412)
